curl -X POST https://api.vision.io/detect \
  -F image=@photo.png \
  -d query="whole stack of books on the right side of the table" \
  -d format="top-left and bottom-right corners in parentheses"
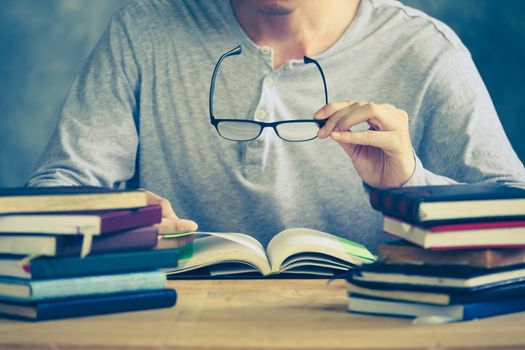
top-left (347, 185), bottom-right (525, 323)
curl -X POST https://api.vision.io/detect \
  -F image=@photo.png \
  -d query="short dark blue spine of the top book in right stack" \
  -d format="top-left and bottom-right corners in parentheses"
top-left (370, 188), bottom-right (420, 224)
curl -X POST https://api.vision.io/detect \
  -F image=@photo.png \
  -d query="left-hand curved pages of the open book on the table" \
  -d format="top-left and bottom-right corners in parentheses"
top-left (166, 232), bottom-right (271, 275)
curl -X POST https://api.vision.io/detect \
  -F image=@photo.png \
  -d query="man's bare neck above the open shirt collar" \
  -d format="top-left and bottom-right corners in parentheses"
top-left (231, 0), bottom-right (359, 68)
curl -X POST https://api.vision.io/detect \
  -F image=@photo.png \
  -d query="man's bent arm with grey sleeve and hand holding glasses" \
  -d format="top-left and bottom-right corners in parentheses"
top-left (314, 50), bottom-right (525, 187)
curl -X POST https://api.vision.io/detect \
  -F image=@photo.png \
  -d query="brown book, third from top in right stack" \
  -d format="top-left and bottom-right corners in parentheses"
top-left (378, 241), bottom-right (525, 269)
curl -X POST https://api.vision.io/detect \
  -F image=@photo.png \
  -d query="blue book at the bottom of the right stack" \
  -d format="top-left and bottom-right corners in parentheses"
top-left (348, 294), bottom-right (525, 322)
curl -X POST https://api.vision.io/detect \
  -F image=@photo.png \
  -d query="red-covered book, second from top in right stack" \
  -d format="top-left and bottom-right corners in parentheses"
top-left (383, 216), bottom-right (525, 250)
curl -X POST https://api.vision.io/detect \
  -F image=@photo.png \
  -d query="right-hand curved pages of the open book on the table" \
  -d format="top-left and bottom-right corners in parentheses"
top-left (267, 228), bottom-right (375, 272)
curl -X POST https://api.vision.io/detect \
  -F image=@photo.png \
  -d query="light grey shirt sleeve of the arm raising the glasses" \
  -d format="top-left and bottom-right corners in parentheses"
top-left (407, 50), bottom-right (525, 186)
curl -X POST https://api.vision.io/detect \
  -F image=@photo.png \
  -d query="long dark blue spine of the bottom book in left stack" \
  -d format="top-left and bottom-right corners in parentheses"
top-left (36, 289), bottom-right (177, 321)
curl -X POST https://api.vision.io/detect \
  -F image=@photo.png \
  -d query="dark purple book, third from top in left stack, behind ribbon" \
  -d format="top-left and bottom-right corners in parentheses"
top-left (0, 226), bottom-right (158, 256)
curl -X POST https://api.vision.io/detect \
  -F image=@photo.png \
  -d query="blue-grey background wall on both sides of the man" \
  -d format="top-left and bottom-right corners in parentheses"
top-left (0, 0), bottom-right (525, 187)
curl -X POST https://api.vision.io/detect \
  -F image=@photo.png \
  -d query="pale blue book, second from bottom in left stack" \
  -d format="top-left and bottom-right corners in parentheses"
top-left (0, 271), bottom-right (166, 302)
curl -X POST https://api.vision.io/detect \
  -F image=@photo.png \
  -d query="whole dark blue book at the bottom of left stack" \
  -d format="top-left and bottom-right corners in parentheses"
top-left (0, 289), bottom-right (177, 321)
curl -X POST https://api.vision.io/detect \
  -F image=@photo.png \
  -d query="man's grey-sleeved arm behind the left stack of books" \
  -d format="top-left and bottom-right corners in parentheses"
top-left (27, 14), bottom-right (139, 188)
